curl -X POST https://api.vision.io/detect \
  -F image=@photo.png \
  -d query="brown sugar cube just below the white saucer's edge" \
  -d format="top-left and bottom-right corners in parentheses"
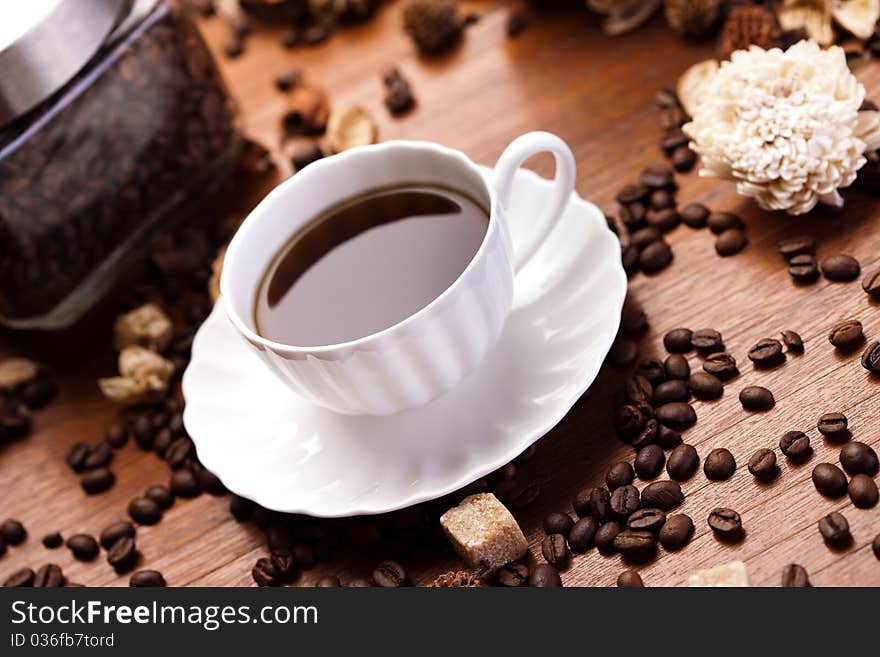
top-left (440, 493), bottom-right (528, 571)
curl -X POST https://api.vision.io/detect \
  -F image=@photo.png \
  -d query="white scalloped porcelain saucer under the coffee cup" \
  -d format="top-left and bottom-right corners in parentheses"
top-left (183, 170), bottom-right (626, 517)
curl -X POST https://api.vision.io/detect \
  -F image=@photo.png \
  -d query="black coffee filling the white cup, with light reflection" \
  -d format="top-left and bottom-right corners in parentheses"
top-left (254, 185), bottom-right (489, 347)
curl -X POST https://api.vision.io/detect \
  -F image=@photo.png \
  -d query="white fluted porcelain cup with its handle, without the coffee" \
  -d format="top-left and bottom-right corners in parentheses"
top-left (218, 132), bottom-right (575, 415)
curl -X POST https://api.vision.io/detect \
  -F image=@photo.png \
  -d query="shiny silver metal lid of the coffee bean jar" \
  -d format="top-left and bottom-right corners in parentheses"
top-left (0, 0), bottom-right (132, 125)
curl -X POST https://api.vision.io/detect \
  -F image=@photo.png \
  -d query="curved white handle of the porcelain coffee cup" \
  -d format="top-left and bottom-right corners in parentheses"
top-left (495, 132), bottom-right (577, 273)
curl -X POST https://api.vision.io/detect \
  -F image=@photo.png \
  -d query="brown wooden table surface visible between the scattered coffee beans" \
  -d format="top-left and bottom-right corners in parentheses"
top-left (0, 1), bottom-right (880, 586)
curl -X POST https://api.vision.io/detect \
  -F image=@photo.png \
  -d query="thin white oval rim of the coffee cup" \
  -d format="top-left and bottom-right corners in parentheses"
top-left (220, 139), bottom-right (498, 356)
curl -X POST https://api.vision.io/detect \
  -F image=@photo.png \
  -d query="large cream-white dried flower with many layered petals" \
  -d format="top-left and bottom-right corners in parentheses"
top-left (683, 41), bottom-right (880, 214)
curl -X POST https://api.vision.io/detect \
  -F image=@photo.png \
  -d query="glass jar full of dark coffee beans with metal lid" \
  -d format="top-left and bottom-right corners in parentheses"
top-left (0, 0), bottom-right (241, 329)
